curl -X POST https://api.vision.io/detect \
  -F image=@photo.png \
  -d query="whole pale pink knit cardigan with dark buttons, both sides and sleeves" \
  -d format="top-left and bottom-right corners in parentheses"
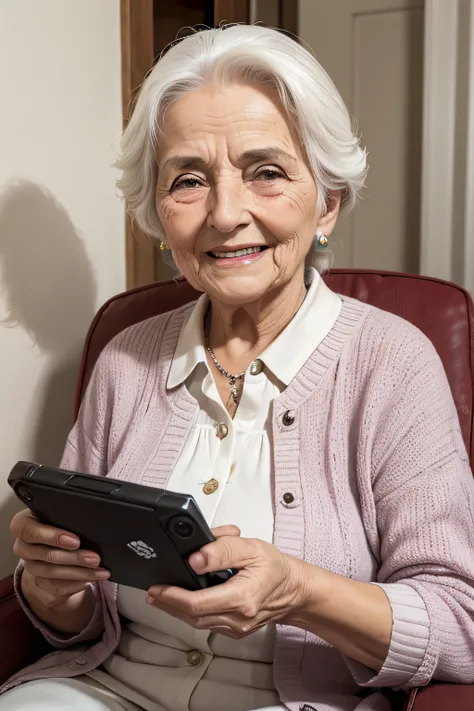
top-left (3, 297), bottom-right (474, 711)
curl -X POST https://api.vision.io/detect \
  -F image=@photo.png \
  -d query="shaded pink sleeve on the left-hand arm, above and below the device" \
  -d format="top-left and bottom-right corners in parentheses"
top-left (14, 349), bottom-right (120, 649)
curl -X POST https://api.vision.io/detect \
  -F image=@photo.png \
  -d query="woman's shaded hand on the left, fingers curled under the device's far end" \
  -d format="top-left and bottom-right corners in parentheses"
top-left (10, 509), bottom-right (110, 632)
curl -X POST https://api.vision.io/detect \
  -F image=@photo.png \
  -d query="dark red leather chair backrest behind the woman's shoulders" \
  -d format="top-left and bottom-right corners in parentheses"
top-left (75, 269), bottom-right (474, 463)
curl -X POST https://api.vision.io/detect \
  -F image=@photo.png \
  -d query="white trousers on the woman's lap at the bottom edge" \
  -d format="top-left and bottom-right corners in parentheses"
top-left (0, 677), bottom-right (285, 711)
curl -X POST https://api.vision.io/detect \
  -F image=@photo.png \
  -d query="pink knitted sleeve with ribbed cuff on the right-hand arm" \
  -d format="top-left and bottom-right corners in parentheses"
top-left (348, 324), bottom-right (474, 687)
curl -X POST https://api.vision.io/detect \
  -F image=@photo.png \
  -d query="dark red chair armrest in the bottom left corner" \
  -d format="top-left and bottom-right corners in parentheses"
top-left (0, 576), bottom-right (49, 684)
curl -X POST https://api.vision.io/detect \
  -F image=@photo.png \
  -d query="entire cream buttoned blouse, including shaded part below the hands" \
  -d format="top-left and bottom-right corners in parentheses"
top-left (91, 270), bottom-right (342, 711)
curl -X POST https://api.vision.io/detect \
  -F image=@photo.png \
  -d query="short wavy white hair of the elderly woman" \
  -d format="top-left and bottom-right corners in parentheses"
top-left (116, 25), bottom-right (366, 270)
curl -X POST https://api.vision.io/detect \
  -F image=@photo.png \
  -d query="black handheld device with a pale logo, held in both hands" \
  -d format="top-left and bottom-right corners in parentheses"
top-left (8, 462), bottom-right (234, 590)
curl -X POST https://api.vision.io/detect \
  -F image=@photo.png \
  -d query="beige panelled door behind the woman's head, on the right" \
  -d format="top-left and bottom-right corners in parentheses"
top-left (298, 0), bottom-right (424, 273)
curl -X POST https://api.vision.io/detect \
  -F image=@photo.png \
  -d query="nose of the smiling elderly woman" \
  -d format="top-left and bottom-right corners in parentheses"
top-left (207, 181), bottom-right (252, 234)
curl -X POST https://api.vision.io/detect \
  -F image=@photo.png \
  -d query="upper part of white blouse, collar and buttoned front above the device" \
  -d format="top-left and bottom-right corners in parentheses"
top-left (167, 270), bottom-right (341, 542)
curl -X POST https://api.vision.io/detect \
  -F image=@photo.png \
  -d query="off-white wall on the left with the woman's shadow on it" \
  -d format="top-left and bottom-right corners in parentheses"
top-left (0, 0), bottom-right (125, 576)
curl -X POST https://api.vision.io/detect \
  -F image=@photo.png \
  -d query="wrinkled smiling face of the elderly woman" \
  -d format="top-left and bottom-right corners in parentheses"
top-left (156, 84), bottom-right (336, 305)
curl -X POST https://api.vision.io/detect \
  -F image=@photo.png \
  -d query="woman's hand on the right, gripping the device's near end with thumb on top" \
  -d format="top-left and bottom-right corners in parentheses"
top-left (147, 526), bottom-right (307, 639)
